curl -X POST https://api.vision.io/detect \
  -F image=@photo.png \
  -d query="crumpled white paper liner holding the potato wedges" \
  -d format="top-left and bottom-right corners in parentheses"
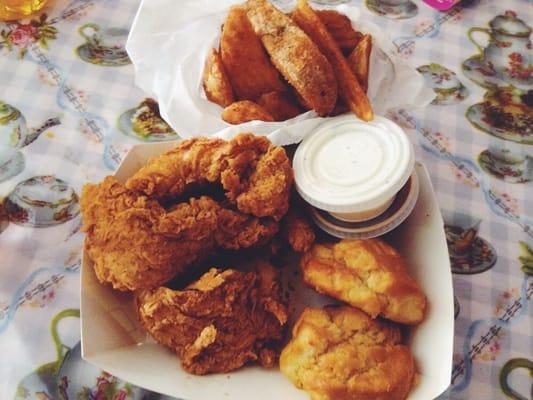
top-left (126, 0), bottom-right (434, 145)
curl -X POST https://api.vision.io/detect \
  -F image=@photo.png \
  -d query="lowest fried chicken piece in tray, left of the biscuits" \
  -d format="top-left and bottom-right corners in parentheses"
top-left (136, 262), bottom-right (288, 375)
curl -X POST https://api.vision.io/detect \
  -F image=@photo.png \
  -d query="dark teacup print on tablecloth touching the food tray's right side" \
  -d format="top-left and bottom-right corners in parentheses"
top-left (442, 210), bottom-right (497, 274)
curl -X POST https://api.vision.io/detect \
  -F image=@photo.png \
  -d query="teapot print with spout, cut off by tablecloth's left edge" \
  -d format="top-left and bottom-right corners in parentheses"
top-left (0, 100), bottom-right (61, 182)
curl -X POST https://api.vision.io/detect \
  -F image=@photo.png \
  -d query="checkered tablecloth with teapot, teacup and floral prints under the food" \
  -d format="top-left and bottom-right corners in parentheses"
top-left (0, 0), bottom-right (533, 400)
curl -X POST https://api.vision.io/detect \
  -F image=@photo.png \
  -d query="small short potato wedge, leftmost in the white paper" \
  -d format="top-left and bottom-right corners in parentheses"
top-left (203, 49), bottom-right (234, 107)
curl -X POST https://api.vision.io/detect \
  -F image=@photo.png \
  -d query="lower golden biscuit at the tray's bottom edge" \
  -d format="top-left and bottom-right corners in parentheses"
top-left (280, 306), bottom-right (415, 400)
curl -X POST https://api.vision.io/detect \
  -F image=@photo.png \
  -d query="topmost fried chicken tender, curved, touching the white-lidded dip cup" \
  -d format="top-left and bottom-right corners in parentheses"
top-left (126, 133), bottom-right (293, 221)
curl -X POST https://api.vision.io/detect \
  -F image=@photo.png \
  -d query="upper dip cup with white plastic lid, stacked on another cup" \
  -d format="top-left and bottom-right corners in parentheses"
top-left (293, 115), bottom-right (415, 222)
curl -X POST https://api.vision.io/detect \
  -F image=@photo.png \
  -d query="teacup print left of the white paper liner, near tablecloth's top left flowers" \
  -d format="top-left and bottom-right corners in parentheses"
top-left (76, 23), bottom-right (131, 67)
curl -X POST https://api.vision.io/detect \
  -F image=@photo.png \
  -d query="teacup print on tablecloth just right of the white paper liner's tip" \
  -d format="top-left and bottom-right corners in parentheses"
top-left (417, 63), bottom-right (468, 105)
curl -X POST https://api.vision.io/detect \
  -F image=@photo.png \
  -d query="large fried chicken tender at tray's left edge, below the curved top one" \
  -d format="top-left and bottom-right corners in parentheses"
top-left (80, 176), bottom-right (278, 291)
